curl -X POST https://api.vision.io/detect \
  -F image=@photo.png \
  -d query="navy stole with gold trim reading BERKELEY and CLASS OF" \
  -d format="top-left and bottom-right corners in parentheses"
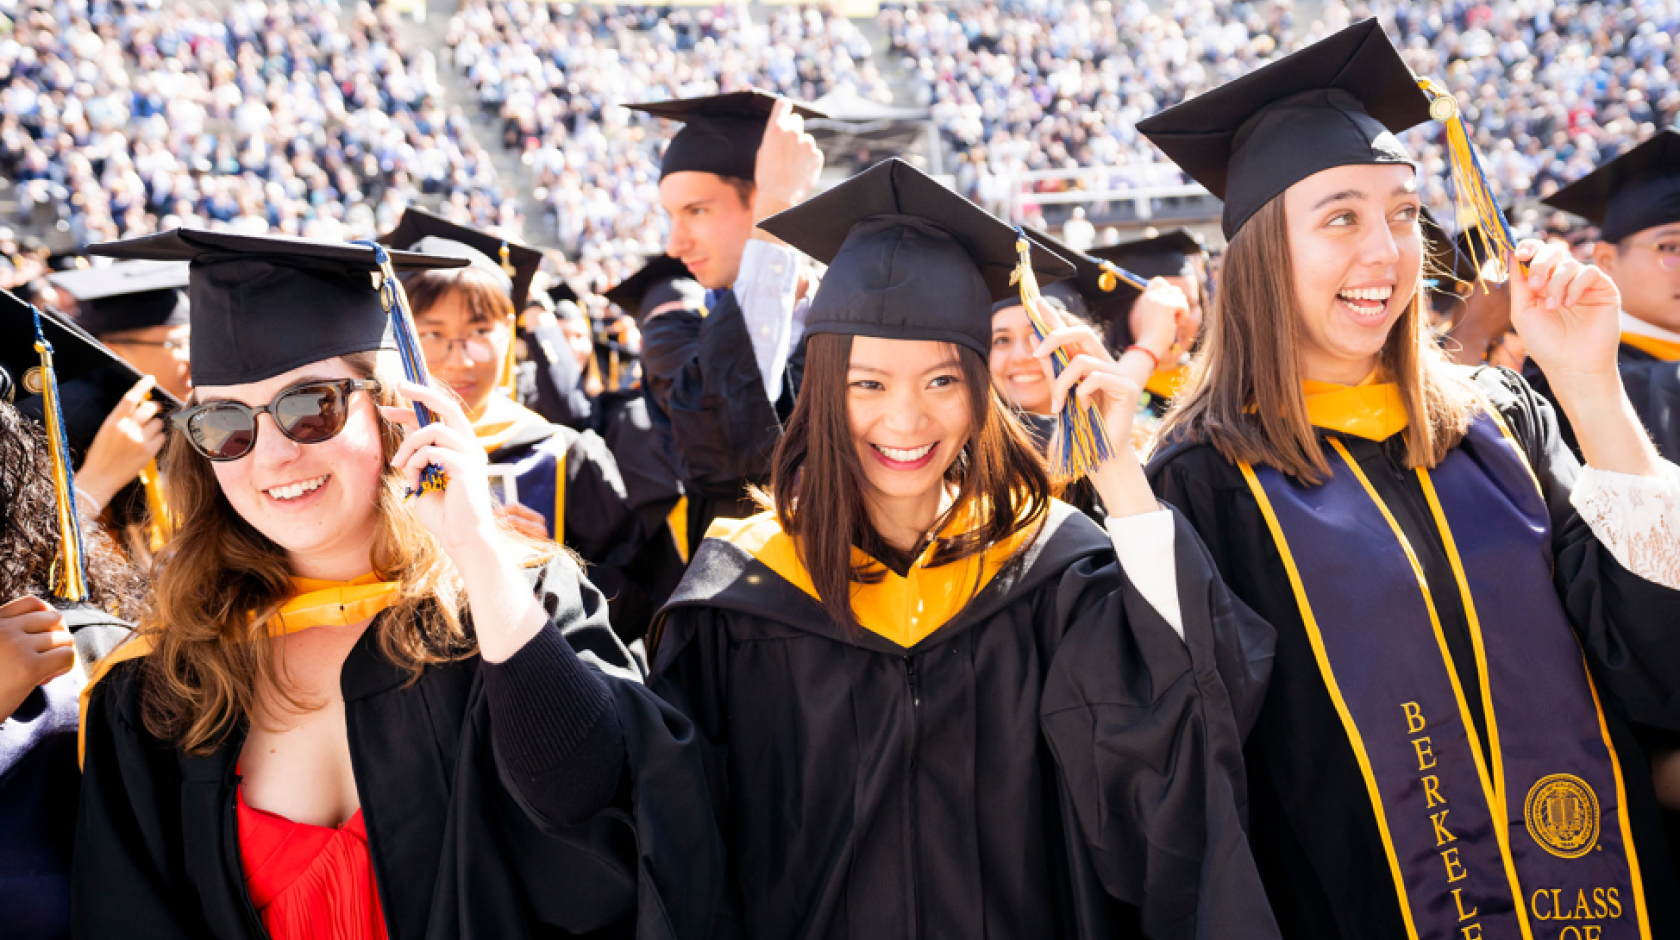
top-left (1242, 415), bottom-right (1650, 940)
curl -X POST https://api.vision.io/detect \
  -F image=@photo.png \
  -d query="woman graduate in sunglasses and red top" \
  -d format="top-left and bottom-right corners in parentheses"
top-left (72, 230), bottom-right (719, 940)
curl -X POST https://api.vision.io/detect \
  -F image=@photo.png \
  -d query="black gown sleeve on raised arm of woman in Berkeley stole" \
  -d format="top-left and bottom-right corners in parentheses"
top-left (1477, 369), bottom-right (1680, 730)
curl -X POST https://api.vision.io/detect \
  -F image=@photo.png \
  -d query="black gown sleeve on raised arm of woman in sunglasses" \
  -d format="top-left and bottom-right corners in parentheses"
top-left (483, 559), bottom-right (724, 938)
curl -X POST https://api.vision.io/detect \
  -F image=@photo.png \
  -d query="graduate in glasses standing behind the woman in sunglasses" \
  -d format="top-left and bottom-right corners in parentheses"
top-left (383, 206), bottom-right (654, 640)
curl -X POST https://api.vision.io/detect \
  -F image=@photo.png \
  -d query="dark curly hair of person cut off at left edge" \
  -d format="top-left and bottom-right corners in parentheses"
top-left (0, 401), bottom-right (146, 621)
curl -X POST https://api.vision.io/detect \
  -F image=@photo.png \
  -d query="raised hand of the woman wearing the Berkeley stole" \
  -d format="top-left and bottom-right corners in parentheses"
top-left (1510, 238), bottom-right (1621, 386)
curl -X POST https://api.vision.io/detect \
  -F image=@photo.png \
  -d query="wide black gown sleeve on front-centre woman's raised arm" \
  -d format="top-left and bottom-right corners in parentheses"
top-left (1040, 514), bottom-right (1280, 940)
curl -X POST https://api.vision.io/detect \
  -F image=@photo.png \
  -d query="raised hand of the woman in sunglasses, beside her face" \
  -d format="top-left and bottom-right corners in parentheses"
top-left (381, 383), bottom-right (499, 557)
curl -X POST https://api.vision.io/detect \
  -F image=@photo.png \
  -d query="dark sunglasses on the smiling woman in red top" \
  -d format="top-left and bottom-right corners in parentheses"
top-left (170, 379), bottom-right (380, 460)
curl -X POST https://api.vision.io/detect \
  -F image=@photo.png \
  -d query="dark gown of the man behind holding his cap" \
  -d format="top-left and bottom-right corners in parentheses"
top-left (642, 290), bottom-right (805, 556)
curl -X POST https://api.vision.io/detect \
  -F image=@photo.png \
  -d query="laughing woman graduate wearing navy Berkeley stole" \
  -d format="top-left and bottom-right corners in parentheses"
top-left (1139, 20), bottom-right (1680, 940)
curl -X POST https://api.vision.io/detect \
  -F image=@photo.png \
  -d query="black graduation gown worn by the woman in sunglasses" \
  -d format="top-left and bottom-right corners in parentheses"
top-left (72, 559), bottom-right (721, 940)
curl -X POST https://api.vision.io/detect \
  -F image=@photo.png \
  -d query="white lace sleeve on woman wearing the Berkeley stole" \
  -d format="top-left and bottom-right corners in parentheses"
top-left (1569, 460), bottom-right (1680, 591)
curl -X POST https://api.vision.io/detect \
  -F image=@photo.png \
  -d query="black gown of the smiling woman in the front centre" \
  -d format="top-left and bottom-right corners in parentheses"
top-left (650, 504), bottom-right (1275, 940)
